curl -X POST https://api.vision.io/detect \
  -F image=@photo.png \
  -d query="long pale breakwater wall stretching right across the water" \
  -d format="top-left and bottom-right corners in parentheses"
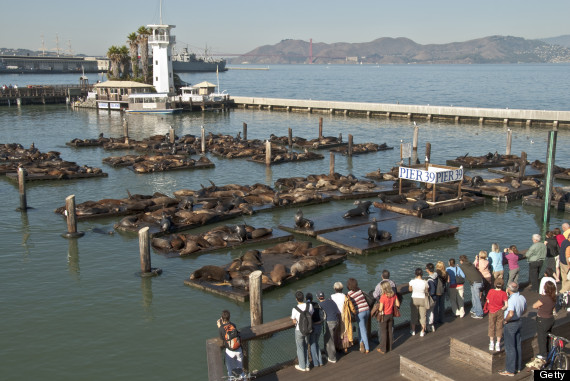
top-left (232, 96), bottom-right (570, 128)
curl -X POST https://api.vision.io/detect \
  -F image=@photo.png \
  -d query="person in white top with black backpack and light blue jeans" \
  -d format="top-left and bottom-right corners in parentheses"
top-left (291, 291), bottom-right (313, 372)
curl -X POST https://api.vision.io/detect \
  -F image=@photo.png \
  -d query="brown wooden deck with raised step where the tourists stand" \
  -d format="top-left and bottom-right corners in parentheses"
top-left (256, 291), bottom-right (570, 381)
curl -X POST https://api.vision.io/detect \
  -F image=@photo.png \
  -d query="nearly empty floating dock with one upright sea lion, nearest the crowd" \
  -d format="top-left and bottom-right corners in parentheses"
top-left (317, 216), bottom-right (459, 255)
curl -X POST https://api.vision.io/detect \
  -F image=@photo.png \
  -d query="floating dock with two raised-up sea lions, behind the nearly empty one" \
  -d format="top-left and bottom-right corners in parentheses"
top-left (279, 209), bottom-right (404, 237)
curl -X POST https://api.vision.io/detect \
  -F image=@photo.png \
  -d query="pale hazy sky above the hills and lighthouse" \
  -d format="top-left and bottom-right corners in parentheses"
top-left (4, 0), bottom-right (570, 55)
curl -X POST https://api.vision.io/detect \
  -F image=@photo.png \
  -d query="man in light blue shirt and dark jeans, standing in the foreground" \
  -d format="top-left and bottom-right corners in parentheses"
top-left (499, 282), bottom-right (526, 376)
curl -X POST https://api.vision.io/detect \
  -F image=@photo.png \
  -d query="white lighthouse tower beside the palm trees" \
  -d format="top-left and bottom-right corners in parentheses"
top-left (147, 20), bottom-right (176, 95)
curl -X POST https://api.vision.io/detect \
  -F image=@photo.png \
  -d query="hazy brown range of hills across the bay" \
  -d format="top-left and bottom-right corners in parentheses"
top-left (232, 36), bottom-right (570, 64)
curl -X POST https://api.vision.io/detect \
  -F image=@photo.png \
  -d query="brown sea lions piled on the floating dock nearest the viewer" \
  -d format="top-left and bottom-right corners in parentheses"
top-left (190, 241), bottom-right (345, 290)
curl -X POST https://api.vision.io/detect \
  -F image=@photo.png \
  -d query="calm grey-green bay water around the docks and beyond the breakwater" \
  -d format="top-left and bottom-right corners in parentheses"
top-left (0, 65), bottom-right (570, 380)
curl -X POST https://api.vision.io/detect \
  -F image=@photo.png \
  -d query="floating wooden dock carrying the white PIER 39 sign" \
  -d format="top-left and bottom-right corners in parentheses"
top-left (374, 196), bottom-right (485, 218)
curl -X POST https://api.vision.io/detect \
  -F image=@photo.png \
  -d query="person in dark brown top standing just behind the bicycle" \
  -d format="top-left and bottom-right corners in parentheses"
top-left (532, 281), bottom-right (556, 359)
